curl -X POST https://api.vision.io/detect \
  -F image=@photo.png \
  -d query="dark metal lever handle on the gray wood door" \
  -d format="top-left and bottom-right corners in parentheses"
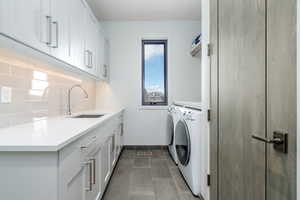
top-left (252, 131), bottom-right (288, 153)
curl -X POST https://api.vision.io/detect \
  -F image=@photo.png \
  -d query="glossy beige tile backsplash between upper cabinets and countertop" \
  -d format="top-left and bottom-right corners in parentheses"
top-left (0, 55), bottom-right (96, 128)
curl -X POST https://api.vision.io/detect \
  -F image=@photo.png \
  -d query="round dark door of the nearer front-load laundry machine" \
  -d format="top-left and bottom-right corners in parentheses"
top-left (175, 120), bottom-right (191, 166)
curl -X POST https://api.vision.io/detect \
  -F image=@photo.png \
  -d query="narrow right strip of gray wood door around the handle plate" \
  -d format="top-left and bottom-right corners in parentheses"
top-left (267, 0), bottom-right (297, 200)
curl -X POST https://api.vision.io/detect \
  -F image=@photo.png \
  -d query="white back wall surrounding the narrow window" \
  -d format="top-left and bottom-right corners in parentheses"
top-left (97, 21), bottom-right (201, 145)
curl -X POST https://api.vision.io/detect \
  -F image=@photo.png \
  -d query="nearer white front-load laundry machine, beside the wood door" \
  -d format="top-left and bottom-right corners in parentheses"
top-left (175, 108), bottom-right (209, 200)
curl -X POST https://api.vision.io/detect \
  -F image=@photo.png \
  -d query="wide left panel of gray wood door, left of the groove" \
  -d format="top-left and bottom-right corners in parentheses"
top-left (219, 0), bottom-right (266, 200)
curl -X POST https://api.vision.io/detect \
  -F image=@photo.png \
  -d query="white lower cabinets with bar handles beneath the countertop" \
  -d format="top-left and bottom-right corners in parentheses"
top-left (0, 111), bottom-right (120, 200)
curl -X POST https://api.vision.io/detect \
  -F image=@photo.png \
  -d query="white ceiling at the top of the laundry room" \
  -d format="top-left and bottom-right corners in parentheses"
top-left (87, 0), bottom-right (201, 20)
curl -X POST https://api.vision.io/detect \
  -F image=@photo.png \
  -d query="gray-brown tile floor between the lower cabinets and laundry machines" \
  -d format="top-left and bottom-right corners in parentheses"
top-left (103, 149), bottom-right (199, 200)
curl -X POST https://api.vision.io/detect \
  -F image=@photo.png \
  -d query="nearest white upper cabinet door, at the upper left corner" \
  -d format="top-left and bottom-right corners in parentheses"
top-left (10, 0), bottom-right (50, 53)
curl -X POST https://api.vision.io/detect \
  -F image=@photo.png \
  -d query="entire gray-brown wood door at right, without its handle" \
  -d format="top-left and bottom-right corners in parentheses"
top-left (212, 0), bottom-right (296, 200)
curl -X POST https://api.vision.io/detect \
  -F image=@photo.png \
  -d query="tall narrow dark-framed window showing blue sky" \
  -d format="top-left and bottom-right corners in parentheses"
top-left (142, 40), bottom-right (168, 105)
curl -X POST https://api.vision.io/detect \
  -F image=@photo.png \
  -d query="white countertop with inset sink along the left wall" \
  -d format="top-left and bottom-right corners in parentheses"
top-left (0, 109), bottom-right (123, 152)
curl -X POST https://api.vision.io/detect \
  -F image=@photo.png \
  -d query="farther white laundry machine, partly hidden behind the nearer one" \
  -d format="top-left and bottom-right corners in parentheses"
top-left (167, 105), bottom-right (182, 165)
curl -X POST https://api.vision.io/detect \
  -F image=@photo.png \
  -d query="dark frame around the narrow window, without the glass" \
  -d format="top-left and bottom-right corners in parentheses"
top-left (142, 40), bottom-right (168, 106)
